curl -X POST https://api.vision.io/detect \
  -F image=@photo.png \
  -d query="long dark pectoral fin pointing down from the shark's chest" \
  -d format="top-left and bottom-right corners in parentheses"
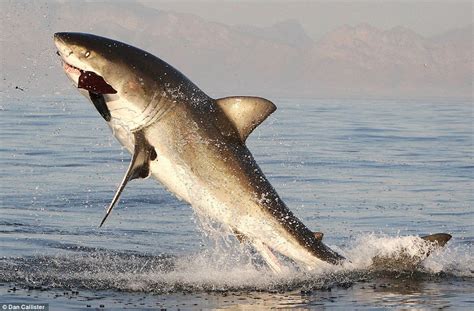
top-left (99, 131), bottom-right (157, 227)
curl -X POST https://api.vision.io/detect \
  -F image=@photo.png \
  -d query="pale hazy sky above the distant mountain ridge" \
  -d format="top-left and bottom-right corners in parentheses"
top-left (139, 0), bottom-right (472, 39)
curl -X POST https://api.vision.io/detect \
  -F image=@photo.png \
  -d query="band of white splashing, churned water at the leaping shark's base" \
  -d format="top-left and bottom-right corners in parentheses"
top-left (0, 234), bottom-right (474, 293)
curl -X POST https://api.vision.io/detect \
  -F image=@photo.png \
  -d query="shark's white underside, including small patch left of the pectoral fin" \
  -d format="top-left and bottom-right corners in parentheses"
top-left (113, 119), bottom-right (327, 269)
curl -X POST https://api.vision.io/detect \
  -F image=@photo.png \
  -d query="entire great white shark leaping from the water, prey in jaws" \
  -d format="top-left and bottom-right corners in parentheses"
top-left (54, 33), bottom-right (452, 272)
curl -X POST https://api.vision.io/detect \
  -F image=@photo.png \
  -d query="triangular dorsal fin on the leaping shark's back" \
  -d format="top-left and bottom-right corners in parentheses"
top-left (216, 96), bottom-right (276, 142)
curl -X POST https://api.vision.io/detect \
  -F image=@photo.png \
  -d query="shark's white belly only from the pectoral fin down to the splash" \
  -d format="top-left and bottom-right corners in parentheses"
top-left (151, 151), bottom-right (327, 269)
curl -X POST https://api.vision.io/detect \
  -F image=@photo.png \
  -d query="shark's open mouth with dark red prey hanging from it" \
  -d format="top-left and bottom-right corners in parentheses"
top-left (58, 52), bottom-right (117, 122)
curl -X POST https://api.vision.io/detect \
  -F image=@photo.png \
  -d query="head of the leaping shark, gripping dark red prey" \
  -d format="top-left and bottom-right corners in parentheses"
top-left (54, 32), bottom-right (175, 129)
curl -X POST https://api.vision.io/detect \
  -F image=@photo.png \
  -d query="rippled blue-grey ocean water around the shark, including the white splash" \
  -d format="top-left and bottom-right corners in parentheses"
top-left (0, 95), bottom-right (474, 310)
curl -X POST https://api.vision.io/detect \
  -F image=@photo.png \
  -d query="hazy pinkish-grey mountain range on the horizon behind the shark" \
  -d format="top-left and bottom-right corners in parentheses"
top-left (0, 1), bottom-right (474, 98)
